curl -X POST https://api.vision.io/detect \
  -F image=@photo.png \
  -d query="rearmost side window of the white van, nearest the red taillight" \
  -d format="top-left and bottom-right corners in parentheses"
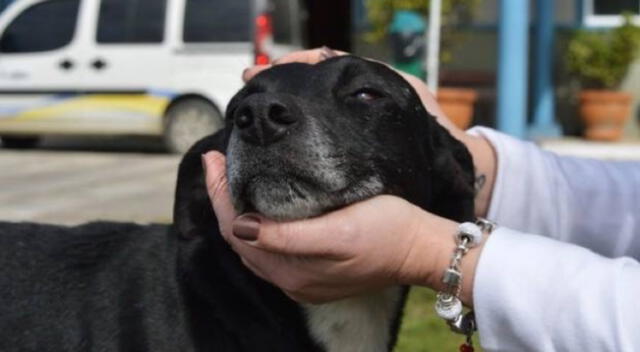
top-left (182, 0), bottom-right (252, 43)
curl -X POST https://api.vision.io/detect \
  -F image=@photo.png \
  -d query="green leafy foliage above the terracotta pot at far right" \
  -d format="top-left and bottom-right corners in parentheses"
top-left (567, 15), bottom-right (640, 89)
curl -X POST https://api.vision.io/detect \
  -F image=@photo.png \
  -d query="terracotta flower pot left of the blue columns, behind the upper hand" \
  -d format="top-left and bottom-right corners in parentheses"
top-left (437, 88), bottom-right (478, 129)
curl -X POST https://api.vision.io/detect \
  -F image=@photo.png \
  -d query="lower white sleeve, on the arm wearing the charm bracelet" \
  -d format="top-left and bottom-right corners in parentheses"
top-left (473, 228), bottom-right (640, 352)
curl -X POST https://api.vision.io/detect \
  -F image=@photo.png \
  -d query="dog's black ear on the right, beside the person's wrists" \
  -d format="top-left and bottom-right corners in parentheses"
top-left (425, 111), bottom-right (475, 221)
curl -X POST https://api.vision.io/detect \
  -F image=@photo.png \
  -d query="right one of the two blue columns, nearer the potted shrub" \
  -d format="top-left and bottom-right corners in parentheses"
top-left (529, 0), bottom-right (562, 139)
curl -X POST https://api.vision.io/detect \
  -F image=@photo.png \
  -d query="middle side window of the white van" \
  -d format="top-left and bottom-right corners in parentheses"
top-left (97, 0), bottom-right (167, 44)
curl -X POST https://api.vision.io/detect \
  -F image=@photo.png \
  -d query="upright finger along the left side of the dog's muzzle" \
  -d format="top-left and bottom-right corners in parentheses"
top-left (202, 151), bottom-right (236, 238)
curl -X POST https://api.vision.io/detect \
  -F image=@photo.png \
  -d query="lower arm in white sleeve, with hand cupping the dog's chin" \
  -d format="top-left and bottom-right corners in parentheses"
top-left (205, 152), bottom-right (640, 351)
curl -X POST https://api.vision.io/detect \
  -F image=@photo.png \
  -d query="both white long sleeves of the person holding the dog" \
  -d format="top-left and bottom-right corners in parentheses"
top-left (471, 128), bottom-right (640, 352)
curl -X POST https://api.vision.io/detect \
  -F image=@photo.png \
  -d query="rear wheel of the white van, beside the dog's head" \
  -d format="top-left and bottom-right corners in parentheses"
top-left (164, 99), bottom-right (224, 154)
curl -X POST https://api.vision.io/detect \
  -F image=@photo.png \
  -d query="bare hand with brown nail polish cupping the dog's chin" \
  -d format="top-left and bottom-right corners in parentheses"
top-left (203, 152), bottom-right (477, 304)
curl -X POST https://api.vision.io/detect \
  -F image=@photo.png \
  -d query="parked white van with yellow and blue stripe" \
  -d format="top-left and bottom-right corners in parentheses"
top-left (0, 0), bottom-right (302, 152)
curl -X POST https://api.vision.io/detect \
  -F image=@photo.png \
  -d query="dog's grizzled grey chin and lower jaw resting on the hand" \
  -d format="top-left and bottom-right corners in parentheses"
top-left (231, 176), bottom-right (384, 221)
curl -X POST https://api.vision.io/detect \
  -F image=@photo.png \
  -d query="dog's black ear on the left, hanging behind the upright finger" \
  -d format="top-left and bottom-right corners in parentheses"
top-left (173, 129), bottom-right (228, 238)
